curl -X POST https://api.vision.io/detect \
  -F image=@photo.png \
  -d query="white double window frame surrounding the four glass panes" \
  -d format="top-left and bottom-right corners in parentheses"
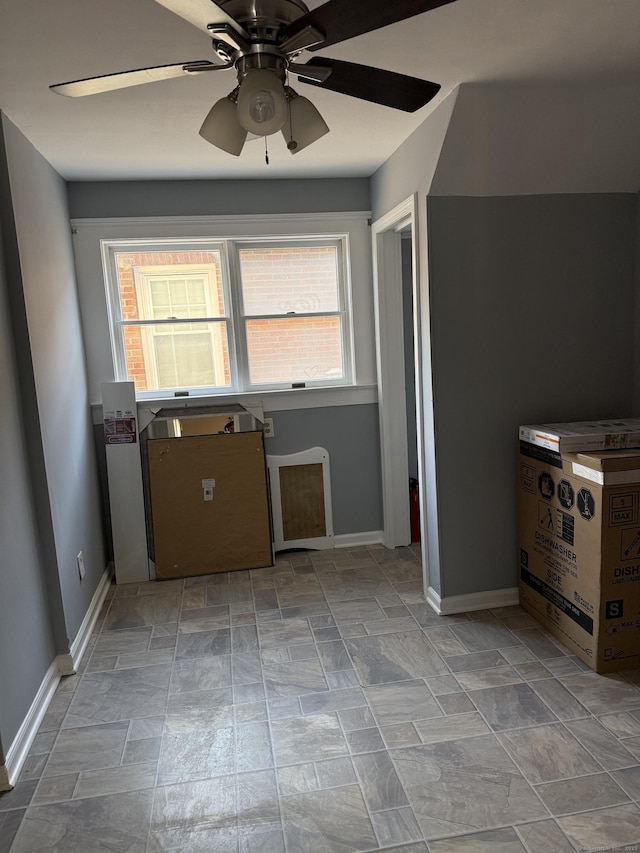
top-left (100, 232), bottom-right (356, 400)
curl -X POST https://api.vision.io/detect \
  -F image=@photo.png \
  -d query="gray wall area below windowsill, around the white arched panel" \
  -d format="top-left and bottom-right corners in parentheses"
top-left (265, 405), bottom-right (382, 536)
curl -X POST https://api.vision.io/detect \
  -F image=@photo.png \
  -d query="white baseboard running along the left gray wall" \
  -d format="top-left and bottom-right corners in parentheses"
top-left (0, 566), bottom-right (112, 791)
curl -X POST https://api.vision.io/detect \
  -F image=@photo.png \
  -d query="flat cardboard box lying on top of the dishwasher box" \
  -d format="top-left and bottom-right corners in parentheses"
top-left (520, 418), bottom-right (640, 453)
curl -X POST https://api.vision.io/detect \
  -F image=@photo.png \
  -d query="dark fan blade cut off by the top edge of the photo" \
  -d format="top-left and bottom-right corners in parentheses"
top-left (282, 0), bottom-right (455, 50)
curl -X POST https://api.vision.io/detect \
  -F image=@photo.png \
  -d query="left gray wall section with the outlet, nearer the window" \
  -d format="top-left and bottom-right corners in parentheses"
top-left (4, 120), bottom-right (106, 640)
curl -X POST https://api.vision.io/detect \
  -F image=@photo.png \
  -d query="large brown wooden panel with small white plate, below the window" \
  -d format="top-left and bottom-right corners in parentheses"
top-left (147, 431), bottom-right (273, 580)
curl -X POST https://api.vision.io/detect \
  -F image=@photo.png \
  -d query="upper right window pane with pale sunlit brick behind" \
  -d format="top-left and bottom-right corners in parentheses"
top-left (239, 246), bottom-right (340, 316)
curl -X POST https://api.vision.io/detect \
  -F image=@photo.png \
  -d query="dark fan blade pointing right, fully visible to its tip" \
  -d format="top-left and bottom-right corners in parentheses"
top-left (295, 56), bottom-right (440, 113)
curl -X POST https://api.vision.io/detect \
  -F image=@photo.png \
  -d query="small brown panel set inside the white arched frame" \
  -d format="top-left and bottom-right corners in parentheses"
top-left (280, 463), bottom-right (327, 542)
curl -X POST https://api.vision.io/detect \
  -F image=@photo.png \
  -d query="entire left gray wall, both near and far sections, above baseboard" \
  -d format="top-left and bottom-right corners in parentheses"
top-left (0, 115), bottom-right (106, 750)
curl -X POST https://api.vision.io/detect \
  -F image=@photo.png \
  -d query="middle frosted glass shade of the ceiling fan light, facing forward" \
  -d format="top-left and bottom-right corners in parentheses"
top-left (237, 68), bottom-right (289, 136)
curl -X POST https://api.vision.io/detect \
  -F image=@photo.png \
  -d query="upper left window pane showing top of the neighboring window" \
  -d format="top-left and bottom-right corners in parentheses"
top-left (115, 253), bottom-right (227, 321)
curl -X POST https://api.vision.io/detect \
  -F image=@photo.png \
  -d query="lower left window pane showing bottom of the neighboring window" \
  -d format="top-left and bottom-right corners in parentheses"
top-left (122, 322), bottom-right (231, 391)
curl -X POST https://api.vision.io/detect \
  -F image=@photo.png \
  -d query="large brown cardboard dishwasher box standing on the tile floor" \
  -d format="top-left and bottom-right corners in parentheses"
top-left (518, 442), bottom-right (640, 673)
